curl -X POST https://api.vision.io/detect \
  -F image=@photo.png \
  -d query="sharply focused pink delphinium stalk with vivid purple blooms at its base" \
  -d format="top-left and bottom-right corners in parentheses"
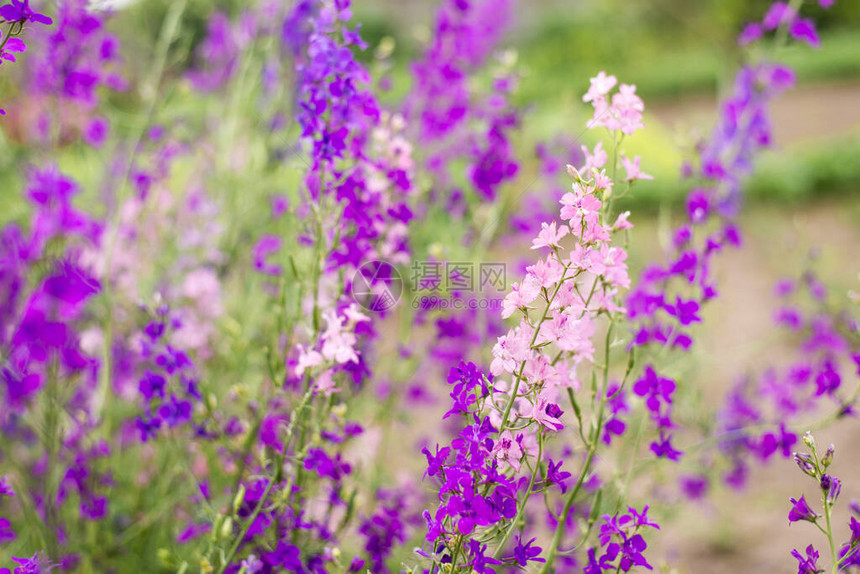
top-left (414, 75), bottom-right (662, 572)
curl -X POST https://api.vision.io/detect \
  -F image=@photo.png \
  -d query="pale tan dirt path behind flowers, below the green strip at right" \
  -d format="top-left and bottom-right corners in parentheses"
top-left (654, 199), bottom-right (860, 574)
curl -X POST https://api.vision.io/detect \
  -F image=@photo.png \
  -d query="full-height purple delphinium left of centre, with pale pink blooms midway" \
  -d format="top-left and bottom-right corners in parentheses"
top-left (206, 1), bottom-right (424, 572)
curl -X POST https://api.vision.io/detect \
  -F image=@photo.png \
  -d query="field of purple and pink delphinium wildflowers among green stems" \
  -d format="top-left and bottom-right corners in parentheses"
top-left (0, 0), bottom-right (860, 574)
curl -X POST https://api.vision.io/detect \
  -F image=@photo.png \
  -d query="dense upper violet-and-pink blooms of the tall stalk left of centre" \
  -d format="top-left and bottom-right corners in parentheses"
top-left (284, 2), bottom-right (413, 270)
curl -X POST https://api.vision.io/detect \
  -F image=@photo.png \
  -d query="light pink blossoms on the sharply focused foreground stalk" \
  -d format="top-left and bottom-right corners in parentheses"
top-left (490, 72), bottom-right (642, 438)
